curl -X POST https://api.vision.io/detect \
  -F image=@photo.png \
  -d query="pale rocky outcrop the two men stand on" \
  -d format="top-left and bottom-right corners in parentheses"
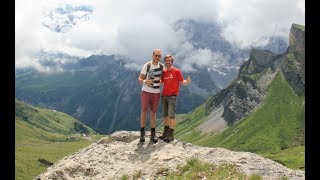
top-left (36, 131), bottom-right (305, 180)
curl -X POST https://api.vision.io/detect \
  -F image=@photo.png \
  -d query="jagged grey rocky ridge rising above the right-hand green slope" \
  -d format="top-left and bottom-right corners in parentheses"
top-left (202, 24), bottom-right (305, 129)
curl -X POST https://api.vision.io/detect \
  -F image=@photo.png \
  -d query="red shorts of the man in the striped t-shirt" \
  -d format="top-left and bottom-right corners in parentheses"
top-left (141, 91), bottom-right (160, 113)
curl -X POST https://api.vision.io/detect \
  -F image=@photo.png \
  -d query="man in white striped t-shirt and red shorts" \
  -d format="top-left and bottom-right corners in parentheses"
top-left (138, 49), bottom-right (164, 143)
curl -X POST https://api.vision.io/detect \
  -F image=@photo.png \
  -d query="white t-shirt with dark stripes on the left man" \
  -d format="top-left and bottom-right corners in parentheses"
top-left (140, 62), bottom-right (164, 93)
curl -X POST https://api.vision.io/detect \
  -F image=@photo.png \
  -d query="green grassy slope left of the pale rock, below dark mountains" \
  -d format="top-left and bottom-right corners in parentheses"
top-left (15, 100), bottom-right (105, 180)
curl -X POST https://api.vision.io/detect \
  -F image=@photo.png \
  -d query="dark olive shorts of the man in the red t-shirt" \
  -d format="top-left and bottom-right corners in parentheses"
top-left (162, 96), bottom-right (177, 118)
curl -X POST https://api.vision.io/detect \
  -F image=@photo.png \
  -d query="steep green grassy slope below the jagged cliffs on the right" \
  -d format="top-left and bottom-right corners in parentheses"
top-left (176, 74), bottom-right (305, 169)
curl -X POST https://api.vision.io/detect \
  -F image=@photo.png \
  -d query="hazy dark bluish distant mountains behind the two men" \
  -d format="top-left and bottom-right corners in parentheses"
top-left (16, 56), bottom-right (219, 133)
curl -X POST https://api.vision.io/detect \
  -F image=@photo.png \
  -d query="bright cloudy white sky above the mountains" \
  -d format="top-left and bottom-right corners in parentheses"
top-left (15, 0), bottom-right (305, 71)
